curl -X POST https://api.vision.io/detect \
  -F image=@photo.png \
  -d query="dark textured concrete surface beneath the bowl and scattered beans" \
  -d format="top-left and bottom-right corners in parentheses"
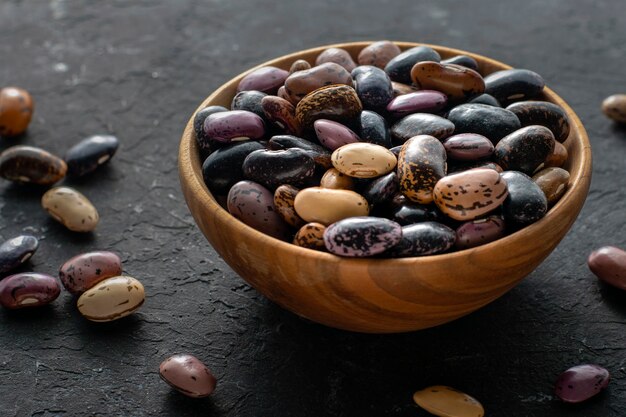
top-left (0, 0), bottom-right (626, 417)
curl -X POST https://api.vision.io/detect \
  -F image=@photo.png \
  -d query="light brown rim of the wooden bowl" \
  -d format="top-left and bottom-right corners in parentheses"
top-left (178, 41), bottom-right (592, 267)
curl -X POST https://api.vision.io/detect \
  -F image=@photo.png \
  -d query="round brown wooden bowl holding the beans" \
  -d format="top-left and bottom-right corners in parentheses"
top-left (179, 42), bottom-right (591, 333)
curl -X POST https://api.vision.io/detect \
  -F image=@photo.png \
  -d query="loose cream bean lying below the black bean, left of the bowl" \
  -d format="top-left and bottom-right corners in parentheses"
top-left (41, 187), bottom-right (100, 232)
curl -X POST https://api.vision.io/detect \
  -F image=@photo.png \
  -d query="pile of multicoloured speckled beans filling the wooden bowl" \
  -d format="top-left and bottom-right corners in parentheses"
top-left (194, 41), bottom-right (570, 257)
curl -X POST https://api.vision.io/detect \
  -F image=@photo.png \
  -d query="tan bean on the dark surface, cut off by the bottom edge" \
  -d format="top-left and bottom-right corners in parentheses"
top-left (413, 385), bottom-right (485, 417)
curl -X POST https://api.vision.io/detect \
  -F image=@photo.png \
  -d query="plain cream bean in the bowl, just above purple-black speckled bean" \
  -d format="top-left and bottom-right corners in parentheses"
top-left (294, 187), bottom-right (369, 226)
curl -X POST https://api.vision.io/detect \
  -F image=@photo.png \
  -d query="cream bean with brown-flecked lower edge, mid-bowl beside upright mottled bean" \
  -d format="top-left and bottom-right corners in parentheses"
top-left (331, 142), bottom-right (398, 178)
